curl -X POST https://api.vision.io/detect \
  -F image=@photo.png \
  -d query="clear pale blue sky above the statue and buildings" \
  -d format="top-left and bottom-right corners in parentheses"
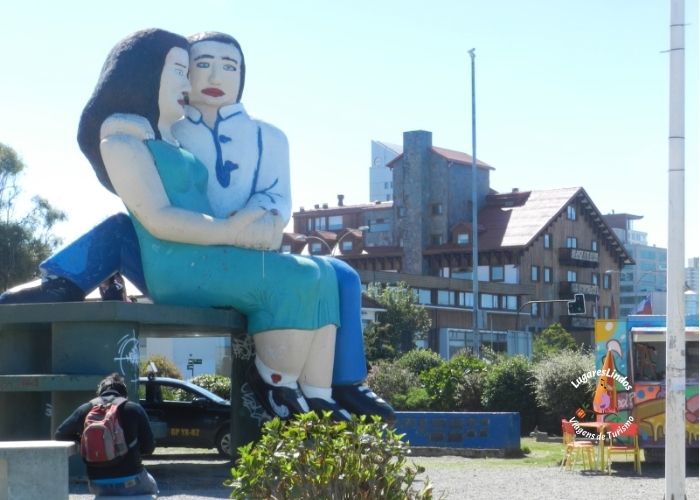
top-left (0, 0), bottom-right (700, 257)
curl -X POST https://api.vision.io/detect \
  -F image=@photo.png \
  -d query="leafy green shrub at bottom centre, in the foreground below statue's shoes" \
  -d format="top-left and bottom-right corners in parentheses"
top-left (224, 413), bottom-right (432, 500)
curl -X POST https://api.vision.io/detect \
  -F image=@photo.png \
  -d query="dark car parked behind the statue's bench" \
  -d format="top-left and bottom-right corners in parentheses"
top-left (139, 377), bottom-right (231, 456)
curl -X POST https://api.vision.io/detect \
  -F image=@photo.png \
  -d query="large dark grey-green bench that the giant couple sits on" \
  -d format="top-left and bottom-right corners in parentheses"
top-left (0, 301), bottom-right (260, 466)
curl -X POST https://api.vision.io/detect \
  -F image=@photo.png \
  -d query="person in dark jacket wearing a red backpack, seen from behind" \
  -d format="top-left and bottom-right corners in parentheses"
top-left (55, 373), bottom-right (158, 496)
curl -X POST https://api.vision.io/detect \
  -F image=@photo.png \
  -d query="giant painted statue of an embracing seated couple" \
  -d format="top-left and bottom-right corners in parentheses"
top-left (0, 29), bottom-right (394, 421)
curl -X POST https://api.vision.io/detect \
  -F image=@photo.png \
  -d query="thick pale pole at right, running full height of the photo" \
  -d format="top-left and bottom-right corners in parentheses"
top-left (665, 0), bottom-right (685, 500)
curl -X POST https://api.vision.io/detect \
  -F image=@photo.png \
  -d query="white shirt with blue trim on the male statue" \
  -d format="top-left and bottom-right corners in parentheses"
top-left (173, 103), bottom-right (292, 224)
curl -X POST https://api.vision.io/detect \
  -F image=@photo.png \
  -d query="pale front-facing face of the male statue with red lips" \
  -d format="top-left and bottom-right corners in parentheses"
top-left (190, 41), bottom-right (241, 108)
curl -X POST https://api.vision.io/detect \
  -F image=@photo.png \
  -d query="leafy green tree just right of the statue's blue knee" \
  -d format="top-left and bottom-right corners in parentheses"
top-left (367, 282), bottom-right (431, 355)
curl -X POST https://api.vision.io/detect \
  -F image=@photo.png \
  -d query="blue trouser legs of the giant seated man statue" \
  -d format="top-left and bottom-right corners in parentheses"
top-left (39, 214), bottom-right (367, 385)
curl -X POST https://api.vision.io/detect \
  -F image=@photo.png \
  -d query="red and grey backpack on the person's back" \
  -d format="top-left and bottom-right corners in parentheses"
top-left (80, 397), bottom-right (136, 466)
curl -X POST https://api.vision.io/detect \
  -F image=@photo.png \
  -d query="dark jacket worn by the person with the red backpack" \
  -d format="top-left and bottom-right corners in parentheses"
top-left (55, 390), bottom-right (156, 479)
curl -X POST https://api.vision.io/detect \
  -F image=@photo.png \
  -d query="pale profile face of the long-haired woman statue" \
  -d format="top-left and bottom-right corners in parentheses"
top-left (158, 47), bottom-right (191, 123)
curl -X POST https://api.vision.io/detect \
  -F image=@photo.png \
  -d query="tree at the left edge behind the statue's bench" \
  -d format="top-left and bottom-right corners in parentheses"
top-left (0, 143), bottom-right (66, 291)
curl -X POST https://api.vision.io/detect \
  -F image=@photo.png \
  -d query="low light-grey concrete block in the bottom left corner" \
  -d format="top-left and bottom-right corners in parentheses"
top-left (0, 441), bottom-right (76, 500)
